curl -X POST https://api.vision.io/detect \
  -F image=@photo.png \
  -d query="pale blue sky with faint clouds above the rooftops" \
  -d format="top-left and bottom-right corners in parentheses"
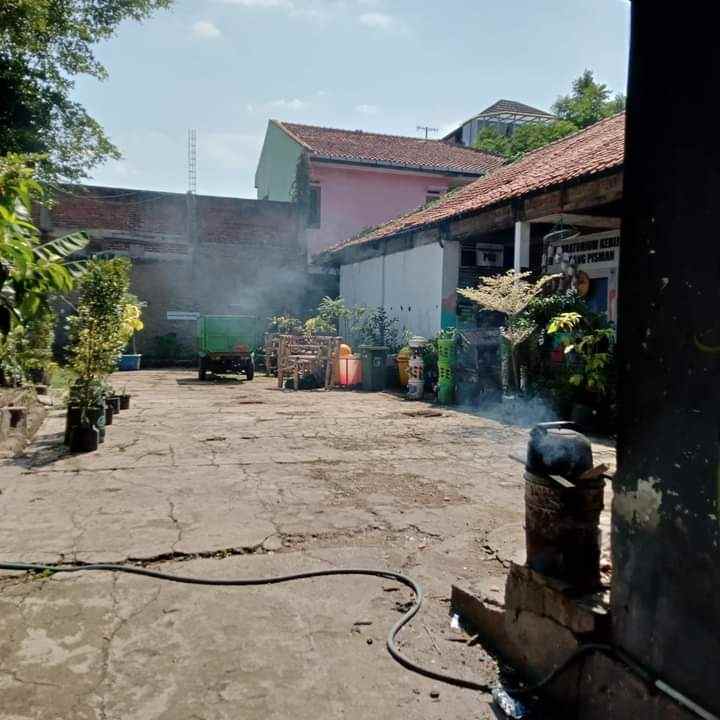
top-left (75, 0), bottom-right (629, 197)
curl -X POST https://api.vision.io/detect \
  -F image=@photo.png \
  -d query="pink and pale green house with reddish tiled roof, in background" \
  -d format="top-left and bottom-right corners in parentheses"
top-left (255, 120), bottom-right (501, 255)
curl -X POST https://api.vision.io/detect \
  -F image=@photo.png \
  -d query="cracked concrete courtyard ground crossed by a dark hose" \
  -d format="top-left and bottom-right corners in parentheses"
top-left (0, 371), bottom-right (614, 720)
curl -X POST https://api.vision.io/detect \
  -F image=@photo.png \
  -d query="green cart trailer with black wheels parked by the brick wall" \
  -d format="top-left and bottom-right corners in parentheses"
top-left (198, 315), bottom-right (259, 380)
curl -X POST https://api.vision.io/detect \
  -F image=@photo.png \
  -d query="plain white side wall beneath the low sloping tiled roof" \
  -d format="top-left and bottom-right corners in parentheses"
top-left (340, 243), bottom-right (443, 337)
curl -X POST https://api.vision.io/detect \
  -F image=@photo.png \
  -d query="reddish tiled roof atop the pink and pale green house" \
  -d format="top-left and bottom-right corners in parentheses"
top-left (273, 120), bottom-right (502, 175)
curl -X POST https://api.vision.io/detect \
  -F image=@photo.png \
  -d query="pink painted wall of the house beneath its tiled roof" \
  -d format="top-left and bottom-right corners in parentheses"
top-left (307, 163), bottom-right (450, 255)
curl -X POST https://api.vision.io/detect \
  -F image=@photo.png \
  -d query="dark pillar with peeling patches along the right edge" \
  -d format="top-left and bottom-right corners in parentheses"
top-left (612, 0), bottom-right (720, 713)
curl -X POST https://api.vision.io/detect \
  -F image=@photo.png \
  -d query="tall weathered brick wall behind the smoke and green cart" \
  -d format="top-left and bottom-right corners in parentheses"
top-left (42, 186), bottom-right (337, 360)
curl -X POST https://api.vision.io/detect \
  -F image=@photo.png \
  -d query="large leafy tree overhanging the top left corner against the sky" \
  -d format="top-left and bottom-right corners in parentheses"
top-left (0, 0), bottom-right (172, 180)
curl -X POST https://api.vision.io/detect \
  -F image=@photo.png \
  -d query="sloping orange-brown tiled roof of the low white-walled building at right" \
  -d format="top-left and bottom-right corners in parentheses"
top-left (326, 113), bottom-right (625, 253)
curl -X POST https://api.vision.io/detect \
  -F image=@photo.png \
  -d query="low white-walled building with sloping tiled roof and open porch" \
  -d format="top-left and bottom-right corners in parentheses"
top-left (316, 114), bottom-right (625, 344)
